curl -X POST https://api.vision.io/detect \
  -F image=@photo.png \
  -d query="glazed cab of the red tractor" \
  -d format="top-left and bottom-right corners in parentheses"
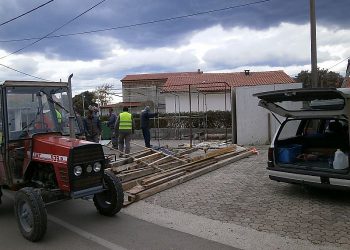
top-left (5, 81), bottom-right (81, 142)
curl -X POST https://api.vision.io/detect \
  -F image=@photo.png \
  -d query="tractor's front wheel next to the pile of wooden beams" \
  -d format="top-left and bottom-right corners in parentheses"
top-left (93, 170), bottom-right (124, 216)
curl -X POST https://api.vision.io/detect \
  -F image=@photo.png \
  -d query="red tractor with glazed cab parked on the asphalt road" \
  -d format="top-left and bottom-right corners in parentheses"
top-left (0, 75), bottom-right (124, 241)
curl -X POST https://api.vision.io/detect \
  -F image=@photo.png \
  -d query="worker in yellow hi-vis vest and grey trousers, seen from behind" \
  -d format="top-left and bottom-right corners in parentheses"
top-left (115, 107), bottom-right (135, 157)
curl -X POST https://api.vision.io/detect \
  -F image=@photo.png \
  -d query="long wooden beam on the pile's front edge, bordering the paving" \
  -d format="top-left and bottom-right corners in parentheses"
top-left (135, 151), bottom-right (254, 201)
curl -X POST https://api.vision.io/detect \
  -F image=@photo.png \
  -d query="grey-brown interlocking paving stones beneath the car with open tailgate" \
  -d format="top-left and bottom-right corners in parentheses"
top-left (139, 144), bottom-right (350, 249)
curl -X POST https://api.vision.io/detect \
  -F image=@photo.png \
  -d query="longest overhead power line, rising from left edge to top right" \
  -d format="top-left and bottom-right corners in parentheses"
top-left (0, 0), bottom-right (271, 42)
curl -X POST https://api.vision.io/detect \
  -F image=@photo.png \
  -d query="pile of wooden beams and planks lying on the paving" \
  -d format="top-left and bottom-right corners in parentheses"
top-left (109, 145), bottom-right (256, 206)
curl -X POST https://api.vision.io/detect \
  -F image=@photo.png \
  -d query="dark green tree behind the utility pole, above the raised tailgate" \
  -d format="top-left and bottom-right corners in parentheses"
top-left (295, 69), bottom-right (344, 88)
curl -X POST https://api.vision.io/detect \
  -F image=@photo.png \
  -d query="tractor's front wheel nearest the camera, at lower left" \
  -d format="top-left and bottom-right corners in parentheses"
top-left (15, 187), bottom-right (47, 241)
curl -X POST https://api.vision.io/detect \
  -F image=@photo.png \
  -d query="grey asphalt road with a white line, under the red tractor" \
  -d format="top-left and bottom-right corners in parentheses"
top-left (0, 191), bottom-right (234, 250)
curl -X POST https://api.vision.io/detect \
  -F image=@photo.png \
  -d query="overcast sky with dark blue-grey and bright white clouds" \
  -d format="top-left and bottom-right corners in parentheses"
top-left (0, 0), bottom-right (350, 97)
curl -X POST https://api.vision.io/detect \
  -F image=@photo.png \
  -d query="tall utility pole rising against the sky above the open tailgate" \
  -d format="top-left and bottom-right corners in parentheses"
top-left (310, 0), bottom-right (320, 88)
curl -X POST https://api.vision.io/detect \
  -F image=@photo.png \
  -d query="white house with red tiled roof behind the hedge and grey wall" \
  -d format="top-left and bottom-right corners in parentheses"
top-left (162, 70), bottom-right (295, 113)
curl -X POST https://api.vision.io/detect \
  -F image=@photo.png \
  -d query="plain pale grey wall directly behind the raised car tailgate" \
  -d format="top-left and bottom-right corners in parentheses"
top-left (236, 83), bottom-right (302, 145)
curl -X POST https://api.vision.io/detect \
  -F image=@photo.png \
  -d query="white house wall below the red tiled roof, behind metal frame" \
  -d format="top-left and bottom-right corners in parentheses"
top-left (165, 91), bottom-right (231, 113)
